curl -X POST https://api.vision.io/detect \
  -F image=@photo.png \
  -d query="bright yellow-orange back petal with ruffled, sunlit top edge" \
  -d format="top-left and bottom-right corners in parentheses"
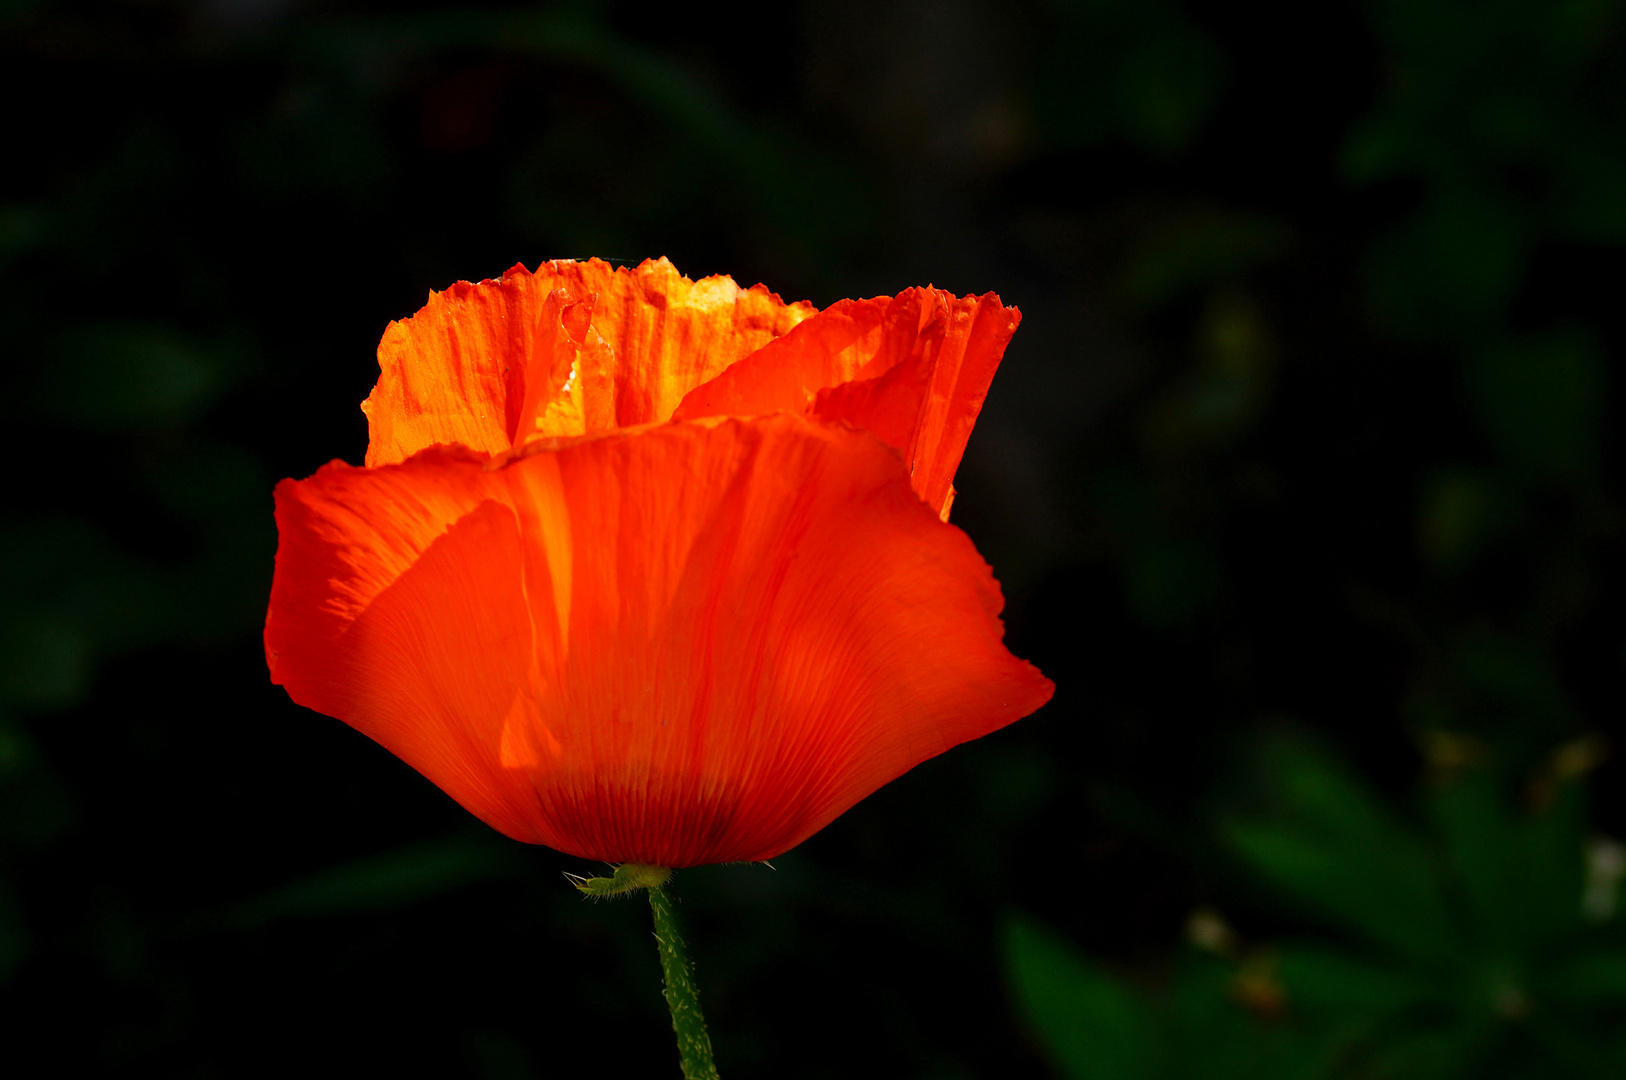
top-left (363, 259), bottom-right (813, 465)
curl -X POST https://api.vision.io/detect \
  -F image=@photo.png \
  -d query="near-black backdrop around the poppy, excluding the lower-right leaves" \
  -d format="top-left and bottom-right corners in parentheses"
top-left (0, 0), bottom-right (1626, 1080)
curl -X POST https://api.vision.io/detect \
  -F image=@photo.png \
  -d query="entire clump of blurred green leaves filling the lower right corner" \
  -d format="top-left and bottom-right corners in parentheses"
top-left (1003, 735), bottom-right (1626, 1080)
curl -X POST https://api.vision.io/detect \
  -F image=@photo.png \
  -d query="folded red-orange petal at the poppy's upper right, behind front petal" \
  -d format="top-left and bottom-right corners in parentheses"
top-left (673, 288), bottom-right (1021, 520)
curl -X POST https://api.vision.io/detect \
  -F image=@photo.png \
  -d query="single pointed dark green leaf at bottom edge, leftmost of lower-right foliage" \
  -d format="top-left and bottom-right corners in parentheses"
top-left (1005, 916), bottom-right (1159, 1080)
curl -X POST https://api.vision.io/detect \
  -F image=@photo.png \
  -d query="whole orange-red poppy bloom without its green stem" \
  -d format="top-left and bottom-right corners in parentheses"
top-left (265, 259), bottom-right (1054, 867)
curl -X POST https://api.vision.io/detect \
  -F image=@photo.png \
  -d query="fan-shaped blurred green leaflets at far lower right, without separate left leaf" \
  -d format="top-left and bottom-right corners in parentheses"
top-left (1216, 732), bottom-right (1626, 1078)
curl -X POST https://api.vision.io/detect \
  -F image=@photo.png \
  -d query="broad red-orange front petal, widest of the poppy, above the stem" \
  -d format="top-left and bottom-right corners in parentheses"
top-left (267, 416), bottom-right (1052, 867)
